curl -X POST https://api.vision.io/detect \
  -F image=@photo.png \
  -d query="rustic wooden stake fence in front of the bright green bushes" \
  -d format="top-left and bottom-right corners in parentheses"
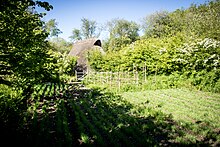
top-left (75, 64), bottom-right (164, 91)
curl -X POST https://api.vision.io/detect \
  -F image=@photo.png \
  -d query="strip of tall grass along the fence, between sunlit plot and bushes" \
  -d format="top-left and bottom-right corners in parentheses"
top-left (83, 72), bottom-right (220, 93)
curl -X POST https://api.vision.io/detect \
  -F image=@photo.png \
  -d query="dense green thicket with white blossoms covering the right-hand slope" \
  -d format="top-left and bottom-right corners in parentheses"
top-left (89, 0), bottom-right (220, 92)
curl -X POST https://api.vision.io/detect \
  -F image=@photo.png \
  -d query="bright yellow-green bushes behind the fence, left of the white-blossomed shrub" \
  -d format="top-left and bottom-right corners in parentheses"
top-left (90, 35), bottom-right (186, 74)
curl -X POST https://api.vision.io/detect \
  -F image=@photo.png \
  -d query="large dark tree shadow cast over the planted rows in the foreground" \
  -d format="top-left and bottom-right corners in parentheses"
top-left (0, 85), bottom-right (219, 147)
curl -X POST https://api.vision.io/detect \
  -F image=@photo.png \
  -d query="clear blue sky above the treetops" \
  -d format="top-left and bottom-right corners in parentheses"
top-left (38, 0), bottom-right (207, 41)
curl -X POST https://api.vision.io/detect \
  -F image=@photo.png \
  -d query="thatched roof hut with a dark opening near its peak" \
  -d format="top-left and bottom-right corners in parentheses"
top-left (69, 38), bottom-right (104, 70)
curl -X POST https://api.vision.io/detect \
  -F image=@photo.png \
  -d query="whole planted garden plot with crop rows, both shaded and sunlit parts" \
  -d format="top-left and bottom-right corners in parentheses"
top-left (0, 84), bottom-right (220, 146)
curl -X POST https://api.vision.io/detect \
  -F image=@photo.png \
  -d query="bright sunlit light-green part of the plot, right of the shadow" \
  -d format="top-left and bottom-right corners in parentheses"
top-left (122, 89), bottom-right (220, 128)
